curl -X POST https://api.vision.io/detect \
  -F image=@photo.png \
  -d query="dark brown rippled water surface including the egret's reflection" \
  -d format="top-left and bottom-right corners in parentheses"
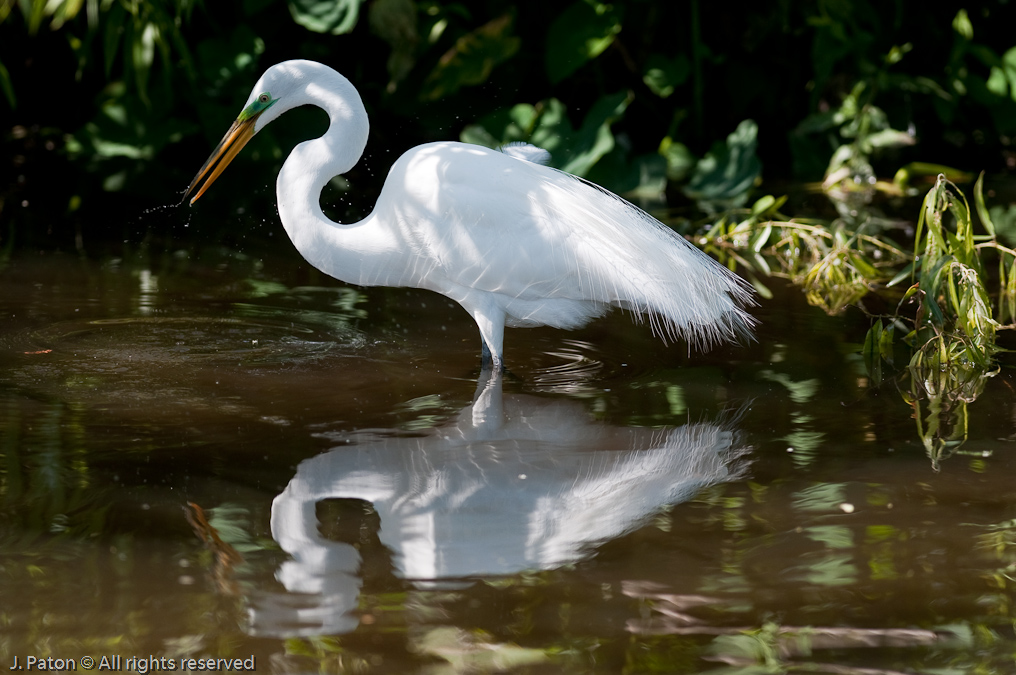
top-left (0, 244), bottom-right (1016, 675)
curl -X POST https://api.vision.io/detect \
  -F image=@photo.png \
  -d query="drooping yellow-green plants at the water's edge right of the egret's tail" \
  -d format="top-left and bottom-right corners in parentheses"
top-left (699, 174), bottom-right (1016, 468)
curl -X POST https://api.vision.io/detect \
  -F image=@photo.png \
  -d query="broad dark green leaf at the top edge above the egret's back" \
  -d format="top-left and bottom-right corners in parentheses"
top-left (546, 0), bottom-right (621, 82)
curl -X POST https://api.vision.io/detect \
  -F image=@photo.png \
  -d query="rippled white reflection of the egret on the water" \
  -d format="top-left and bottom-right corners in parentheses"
top-left (253, 374), bottom-right (745, 634)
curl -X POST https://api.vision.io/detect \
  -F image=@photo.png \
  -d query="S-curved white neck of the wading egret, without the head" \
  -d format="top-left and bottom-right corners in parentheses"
top-left (275, 64), bottom-right (394, 285)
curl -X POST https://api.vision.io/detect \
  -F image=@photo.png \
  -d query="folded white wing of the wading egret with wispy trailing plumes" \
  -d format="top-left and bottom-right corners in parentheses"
top-left (379, 143), bottom-right (752, 344)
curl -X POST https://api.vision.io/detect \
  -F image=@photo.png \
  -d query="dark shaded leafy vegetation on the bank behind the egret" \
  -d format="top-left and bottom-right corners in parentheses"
top-left (0, 0), bottom-right (1016, 248)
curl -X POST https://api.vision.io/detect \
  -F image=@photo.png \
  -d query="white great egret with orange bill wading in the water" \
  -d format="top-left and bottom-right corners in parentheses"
top-left (184, 61), bottom-right (754, 370)
